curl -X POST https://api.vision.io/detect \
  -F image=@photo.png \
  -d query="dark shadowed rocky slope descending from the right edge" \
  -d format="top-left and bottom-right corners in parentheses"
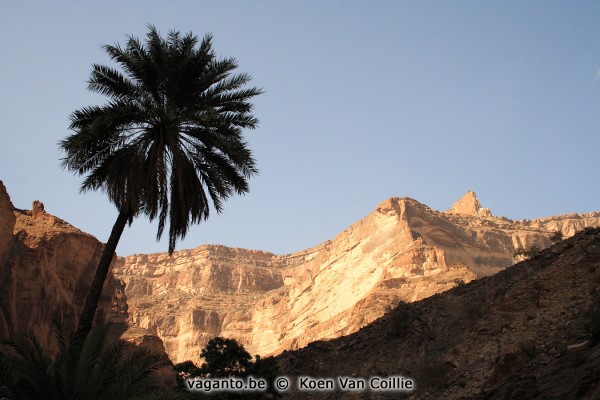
top-left (278, 228), bottom-right (600, 400)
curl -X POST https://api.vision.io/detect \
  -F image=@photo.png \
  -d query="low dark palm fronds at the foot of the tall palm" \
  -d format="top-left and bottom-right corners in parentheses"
top-left (0, 321), bottom-right (188, 400)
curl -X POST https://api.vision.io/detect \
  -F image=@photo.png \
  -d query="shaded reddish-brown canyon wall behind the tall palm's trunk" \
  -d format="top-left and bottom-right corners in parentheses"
top-left (0, 181), bottom-right (158, 352)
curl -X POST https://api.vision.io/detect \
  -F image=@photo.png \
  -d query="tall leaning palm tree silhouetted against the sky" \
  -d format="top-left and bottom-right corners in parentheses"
top-left (59, 26), bottom-right (262, 335)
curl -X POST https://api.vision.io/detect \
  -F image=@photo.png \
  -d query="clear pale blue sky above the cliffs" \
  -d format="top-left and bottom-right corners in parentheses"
top-left (0, 0), bottom-right (600, 255)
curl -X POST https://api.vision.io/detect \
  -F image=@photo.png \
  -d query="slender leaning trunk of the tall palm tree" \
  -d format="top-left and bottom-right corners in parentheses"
top-left (77, 211), bottom-right (129, 338)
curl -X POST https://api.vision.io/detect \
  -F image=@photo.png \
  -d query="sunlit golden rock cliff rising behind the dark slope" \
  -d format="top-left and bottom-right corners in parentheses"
top-left (114, 192), bottom-right (600, 362)
